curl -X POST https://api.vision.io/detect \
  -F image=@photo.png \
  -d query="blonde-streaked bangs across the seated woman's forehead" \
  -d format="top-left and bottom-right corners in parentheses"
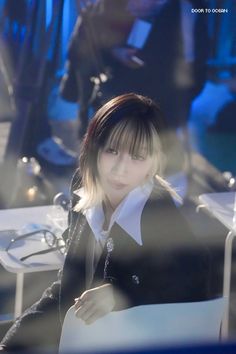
top-left (105, 119), bottom-right (158, 155)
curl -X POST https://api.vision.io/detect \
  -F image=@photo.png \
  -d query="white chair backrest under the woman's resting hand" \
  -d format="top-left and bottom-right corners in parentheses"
top-left (59, 298), bottom-right (225, 353)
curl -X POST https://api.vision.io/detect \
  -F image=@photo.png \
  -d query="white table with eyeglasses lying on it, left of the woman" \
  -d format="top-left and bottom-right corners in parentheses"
top-left (0, 205), bottom-right (66, 318)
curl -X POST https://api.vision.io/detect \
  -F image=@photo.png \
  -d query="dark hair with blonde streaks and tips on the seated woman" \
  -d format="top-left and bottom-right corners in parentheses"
top-left (74, 93), bottom-right (181, 211)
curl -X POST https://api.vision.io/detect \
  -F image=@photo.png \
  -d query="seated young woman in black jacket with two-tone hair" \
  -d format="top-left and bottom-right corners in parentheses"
top-left (2, 93), bottom-right (208, 350)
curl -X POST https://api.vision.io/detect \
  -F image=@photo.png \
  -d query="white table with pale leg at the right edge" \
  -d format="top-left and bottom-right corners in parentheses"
top-left (199, 192), bottom-right (236, 337)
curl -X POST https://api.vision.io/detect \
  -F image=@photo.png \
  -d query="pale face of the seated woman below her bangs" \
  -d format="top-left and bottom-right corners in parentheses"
top-left (98, 146), bottom-right (154, 208)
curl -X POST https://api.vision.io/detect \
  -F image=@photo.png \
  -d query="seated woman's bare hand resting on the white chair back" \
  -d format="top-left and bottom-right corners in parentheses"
top-left (75, 284), bottom-right (115, 324)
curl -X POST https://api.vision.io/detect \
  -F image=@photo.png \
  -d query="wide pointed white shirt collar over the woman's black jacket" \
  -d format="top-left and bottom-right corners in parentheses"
top-left (76, 181), bottom-right (153, 245)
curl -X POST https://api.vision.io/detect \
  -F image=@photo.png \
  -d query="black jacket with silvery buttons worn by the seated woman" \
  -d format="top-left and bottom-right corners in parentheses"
top-left (2, 183), bottom-right (209, 350)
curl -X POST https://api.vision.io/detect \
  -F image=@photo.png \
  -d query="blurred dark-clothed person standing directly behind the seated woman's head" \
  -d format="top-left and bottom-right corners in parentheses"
top-left (61, 0), bottom-right (208, 172)
